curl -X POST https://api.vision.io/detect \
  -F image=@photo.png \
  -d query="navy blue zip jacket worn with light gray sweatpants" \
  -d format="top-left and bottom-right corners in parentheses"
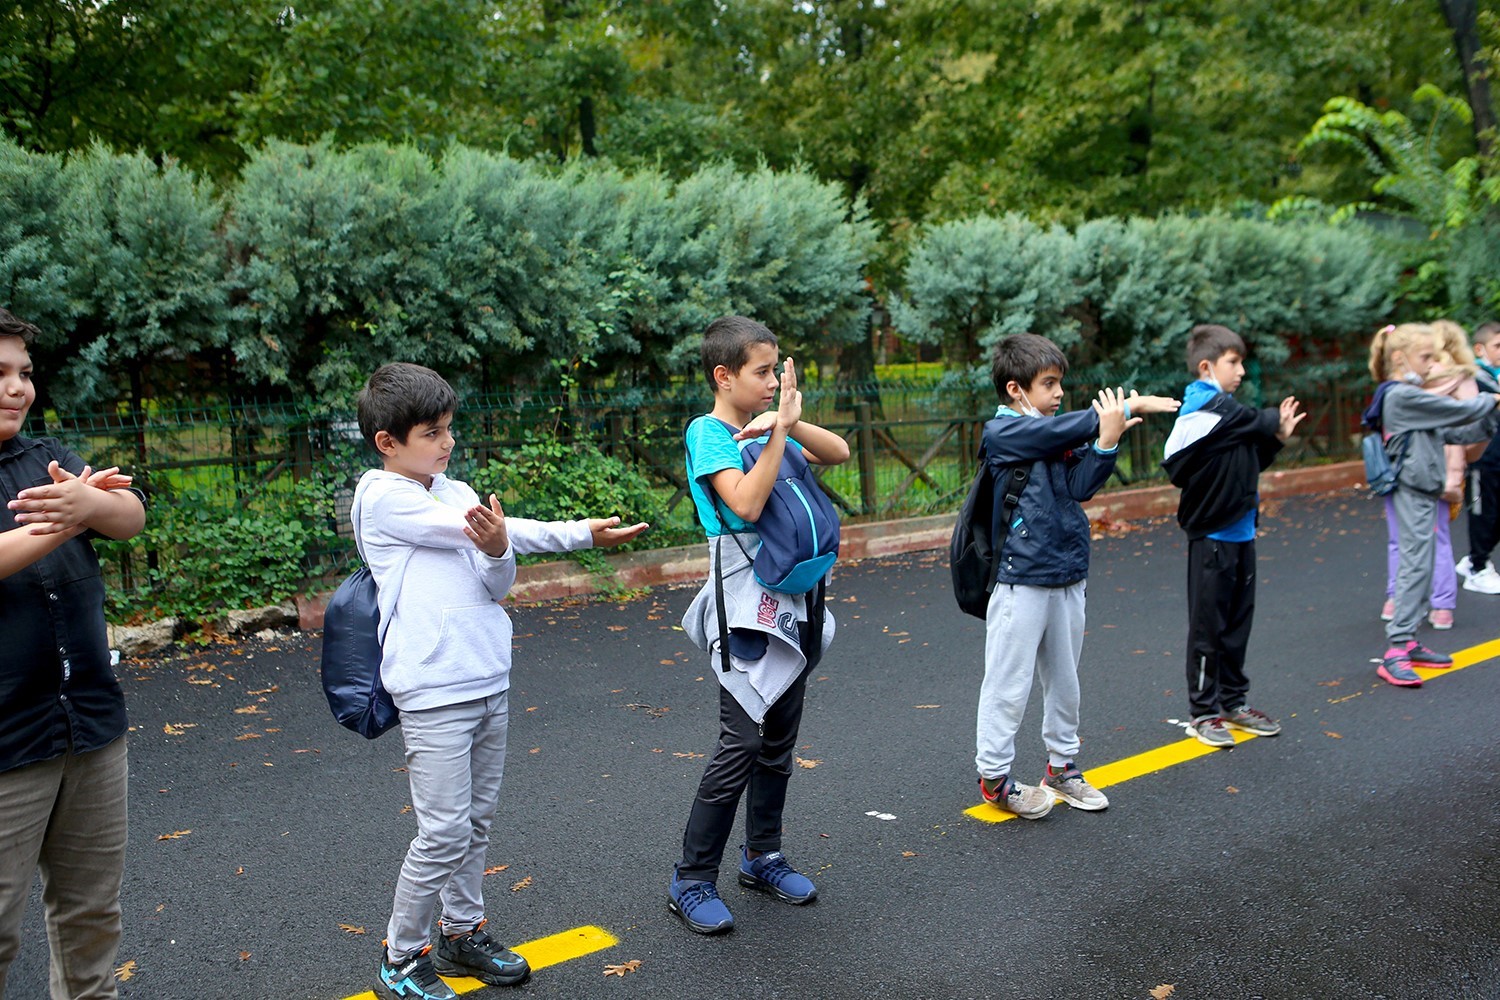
top-left (980, 406), bottom-right (1115, 586)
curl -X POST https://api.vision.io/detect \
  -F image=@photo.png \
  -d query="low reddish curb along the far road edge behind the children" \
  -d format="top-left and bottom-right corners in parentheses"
top-left (297, 462), bottom-right (1365, 628)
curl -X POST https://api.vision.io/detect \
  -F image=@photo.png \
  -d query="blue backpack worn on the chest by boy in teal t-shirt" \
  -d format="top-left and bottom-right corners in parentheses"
top-left (704, 417), bottom-right (839, 594)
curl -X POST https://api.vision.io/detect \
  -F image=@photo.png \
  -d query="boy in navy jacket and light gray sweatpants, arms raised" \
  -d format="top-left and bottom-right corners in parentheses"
top-left (975, 333), bottom-right (1178, 820)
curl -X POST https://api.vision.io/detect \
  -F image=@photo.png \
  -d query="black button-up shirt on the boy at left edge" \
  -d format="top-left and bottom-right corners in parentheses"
top-left (0, 436), bottom-right (126, 771)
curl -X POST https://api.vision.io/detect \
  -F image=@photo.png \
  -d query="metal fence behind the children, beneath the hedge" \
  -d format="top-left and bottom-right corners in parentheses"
top-left (33, 361), bottom-right (1370, 611)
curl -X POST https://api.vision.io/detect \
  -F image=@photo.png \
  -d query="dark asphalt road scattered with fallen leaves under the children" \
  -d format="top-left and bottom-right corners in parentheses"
top-left (9, 495), bottom-right (1500, 1000)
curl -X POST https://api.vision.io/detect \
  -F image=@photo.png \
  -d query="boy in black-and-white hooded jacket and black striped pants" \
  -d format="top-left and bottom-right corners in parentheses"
top-left (1163, 325), bottom-right (1307, 747)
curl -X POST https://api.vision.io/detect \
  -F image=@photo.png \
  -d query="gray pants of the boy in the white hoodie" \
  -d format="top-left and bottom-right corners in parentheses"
top-left (386, 691), bottom-right (510, 963)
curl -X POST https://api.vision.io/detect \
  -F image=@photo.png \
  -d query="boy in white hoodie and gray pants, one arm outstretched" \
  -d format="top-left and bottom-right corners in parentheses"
top-left (360, 363), bottom-right (647, 1000)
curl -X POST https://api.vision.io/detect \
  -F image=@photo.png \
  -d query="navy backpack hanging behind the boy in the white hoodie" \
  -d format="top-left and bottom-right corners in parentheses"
top-left (323, 505), bottom-right (401, 739)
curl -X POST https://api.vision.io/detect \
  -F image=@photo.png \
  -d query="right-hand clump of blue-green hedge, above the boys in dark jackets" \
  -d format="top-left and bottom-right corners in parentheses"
top-left (891, 216), bottom-right (1395, 372)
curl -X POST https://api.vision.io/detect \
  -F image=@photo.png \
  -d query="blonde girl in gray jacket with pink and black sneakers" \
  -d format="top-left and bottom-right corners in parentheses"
top-left (1367, 324), bottom-right (1500, 687)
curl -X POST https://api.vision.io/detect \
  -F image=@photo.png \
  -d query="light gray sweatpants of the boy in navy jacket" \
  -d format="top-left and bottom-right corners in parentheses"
top-left (974, 580), bottom-right (1088, 778)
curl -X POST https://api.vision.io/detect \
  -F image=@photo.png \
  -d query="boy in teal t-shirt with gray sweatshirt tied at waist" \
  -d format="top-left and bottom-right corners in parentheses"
top-left (668, 316), bottom-right (849, 934)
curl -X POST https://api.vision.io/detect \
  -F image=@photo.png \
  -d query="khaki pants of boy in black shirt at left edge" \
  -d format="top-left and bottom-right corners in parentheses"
top-left (0, 736), bottom-right (129, 1000)
